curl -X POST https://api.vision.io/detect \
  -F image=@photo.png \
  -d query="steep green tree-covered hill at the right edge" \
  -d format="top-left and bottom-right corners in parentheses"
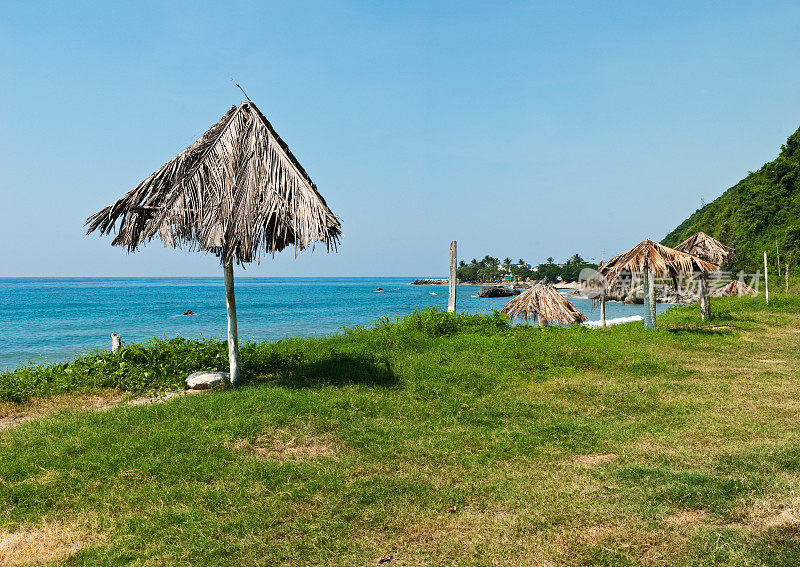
top-left (662, 129), bottom-right (800, 270)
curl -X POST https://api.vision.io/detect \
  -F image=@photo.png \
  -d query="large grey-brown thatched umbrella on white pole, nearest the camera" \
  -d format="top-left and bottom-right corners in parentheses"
top-left (86, 100), bottom-right (341, 384)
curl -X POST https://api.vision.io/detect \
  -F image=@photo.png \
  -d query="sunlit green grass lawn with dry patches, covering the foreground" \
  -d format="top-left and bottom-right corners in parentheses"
top-left (0, 300), bottom-right (800, 566)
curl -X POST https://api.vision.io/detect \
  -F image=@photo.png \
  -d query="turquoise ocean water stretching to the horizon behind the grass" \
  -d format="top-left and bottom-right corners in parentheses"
top-left (0, 277), bottom-right (666, 368)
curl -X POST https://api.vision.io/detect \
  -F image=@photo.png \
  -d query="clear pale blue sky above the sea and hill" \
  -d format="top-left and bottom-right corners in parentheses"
top-left (0, 2), bottom-right (800, 276)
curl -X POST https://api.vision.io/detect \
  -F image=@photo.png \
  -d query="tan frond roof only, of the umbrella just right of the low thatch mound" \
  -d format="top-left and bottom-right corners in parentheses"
top-left (598, 239), bottom-right (717, 287)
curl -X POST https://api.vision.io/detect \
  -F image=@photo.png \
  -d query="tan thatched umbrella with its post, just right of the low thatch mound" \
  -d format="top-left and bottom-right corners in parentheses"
top-left (599, 239), bottom-right (716, 329)
